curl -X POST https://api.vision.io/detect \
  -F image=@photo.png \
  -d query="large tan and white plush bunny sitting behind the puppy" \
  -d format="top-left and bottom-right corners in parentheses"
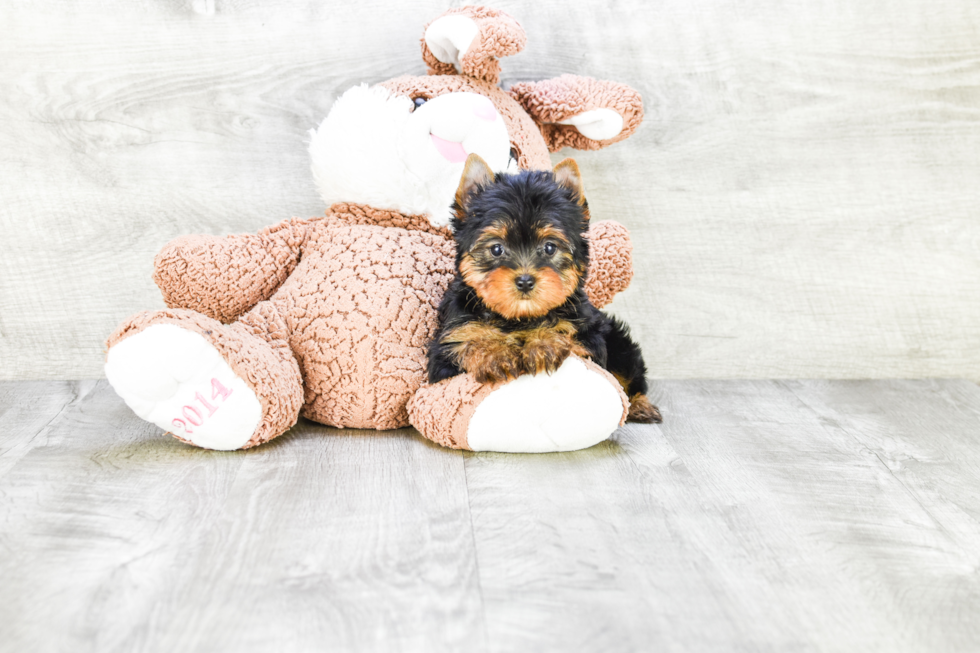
top-left (105, 7), bottom-right (642, 451)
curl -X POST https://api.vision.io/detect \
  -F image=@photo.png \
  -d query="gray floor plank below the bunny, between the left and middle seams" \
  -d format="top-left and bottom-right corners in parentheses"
top-left (0, 381), bottom-right (485, 652)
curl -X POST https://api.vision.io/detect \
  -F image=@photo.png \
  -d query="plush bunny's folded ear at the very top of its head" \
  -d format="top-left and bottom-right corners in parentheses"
top-left (422, 7), bottom-right (527, 84)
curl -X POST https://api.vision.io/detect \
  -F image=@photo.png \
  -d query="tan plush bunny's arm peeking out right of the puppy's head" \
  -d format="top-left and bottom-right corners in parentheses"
top-left (585, 220), bottom-right (633, 308)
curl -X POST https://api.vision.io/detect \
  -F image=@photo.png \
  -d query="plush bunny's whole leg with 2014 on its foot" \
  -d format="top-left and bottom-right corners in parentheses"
top-left (105, 302), bottom-right (303, 450)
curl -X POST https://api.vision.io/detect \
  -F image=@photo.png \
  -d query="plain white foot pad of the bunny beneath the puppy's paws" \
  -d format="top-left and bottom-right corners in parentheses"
top-left (466, 358), bottom-right (623, 453)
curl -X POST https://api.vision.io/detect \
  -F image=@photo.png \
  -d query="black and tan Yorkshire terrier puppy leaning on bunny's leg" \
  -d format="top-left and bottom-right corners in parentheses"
top-left (428, 154), bottom-right (661, 423)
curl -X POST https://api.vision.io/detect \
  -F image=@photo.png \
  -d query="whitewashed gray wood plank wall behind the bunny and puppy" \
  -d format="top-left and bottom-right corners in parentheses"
top-left (0, 0), bottom-right (980, 379)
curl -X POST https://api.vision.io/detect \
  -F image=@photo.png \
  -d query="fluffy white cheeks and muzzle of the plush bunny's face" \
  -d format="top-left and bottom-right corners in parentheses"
top-left (310, 84), bottom-right (516, 226)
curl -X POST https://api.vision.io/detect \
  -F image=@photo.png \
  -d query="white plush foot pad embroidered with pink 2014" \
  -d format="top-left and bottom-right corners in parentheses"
top-left (105, 324), bottom-right (262, 451)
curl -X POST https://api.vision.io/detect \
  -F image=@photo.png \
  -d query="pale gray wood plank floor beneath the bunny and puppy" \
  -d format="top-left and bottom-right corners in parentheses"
top-left (0, 380), bottom-right (980, 652)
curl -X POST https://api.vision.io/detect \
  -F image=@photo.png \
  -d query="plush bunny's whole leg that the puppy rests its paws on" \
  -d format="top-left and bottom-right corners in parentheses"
top-left (408, 356), bottom-right (629, 453)
